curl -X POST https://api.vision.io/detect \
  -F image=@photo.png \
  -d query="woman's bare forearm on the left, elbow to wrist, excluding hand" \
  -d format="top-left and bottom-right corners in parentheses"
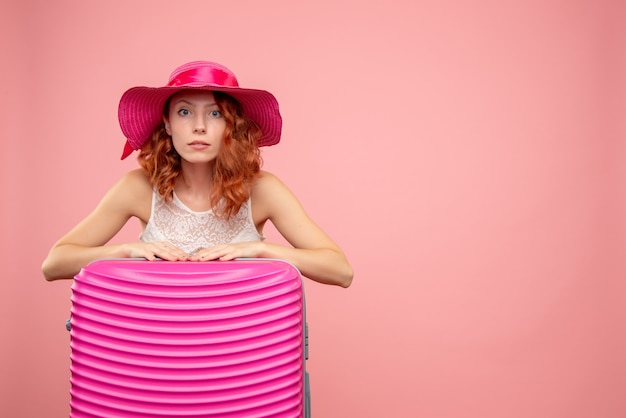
top-left (41, 244), bottom-right (128, 281)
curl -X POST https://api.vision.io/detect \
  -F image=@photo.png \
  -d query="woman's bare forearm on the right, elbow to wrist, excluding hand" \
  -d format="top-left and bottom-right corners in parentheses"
top-left (259, 242), bottom-right (353, 287)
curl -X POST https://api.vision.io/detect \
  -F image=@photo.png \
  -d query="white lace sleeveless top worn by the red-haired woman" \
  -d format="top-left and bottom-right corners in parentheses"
top-left (139, 190), bottom-right (264, 254)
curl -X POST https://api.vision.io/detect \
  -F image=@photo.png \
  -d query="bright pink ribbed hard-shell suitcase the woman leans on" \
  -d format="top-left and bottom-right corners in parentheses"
top-left (70, 259), bottom-right (310, 418)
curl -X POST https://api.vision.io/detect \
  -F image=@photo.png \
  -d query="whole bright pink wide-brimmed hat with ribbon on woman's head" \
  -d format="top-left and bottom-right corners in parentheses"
top-left (118, 61), bottom-right (282, 159)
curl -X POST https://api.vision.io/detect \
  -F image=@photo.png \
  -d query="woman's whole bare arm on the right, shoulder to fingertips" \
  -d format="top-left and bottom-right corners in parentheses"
top-left (194, 172), bottom-right (353, 287)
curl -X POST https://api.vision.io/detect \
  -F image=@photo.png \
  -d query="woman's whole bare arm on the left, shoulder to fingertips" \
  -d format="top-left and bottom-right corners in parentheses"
top-left (41, 170), bottom-right (186, 280)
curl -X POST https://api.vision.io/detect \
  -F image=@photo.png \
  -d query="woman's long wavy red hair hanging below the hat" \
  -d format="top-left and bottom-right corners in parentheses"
top-left (137, 92), bottom-right (262, 219)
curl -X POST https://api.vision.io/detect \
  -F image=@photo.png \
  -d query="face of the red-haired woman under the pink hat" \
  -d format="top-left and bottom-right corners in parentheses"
top-left (163, 90), bottom-right (226, 163)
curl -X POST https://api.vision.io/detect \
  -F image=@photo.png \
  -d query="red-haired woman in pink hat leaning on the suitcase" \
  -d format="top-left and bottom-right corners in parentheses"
top-left (42, 61), bottom-right (353, 287)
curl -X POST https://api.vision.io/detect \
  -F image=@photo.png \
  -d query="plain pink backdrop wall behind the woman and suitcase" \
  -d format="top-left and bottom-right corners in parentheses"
top-left (0, 0), bottom-right (626, 418)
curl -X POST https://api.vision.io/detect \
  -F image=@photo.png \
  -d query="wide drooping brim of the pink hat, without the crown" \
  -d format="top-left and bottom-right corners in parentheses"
top-left (118, 84), bottom-right (282, 159)
